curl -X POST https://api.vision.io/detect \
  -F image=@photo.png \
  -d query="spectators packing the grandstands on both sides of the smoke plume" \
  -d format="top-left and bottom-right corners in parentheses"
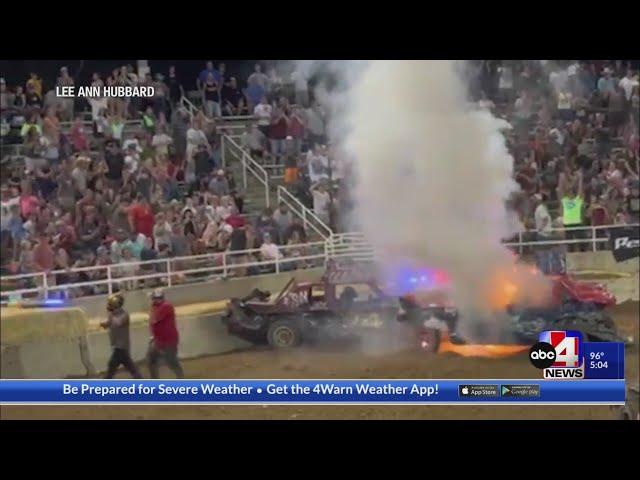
top-left (0, 61), bottom-right (640, 294)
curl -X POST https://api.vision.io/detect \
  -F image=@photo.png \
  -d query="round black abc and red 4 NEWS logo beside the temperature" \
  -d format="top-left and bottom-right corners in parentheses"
top-left (529, 330), bottom-right (584, 379)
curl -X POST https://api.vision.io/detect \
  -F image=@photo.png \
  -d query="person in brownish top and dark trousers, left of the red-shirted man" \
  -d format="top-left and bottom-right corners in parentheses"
top-left (100, 293), bottom-right (142, 378)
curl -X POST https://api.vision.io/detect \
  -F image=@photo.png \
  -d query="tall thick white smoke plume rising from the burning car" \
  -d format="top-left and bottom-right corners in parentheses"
top-left (292, 60), bottom-right (552, 324)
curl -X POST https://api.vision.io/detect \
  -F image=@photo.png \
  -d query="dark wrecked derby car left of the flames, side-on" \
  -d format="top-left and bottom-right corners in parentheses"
top-left (223, 264), bottom-right (438, 348)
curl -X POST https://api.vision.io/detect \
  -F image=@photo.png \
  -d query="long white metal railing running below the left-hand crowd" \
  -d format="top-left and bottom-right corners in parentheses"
top-left (0, 242), bottom-right (326, 300)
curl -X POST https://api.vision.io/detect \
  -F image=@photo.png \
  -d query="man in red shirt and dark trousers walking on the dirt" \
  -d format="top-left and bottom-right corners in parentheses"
top-left (147, 289), bottom-right (184, 378)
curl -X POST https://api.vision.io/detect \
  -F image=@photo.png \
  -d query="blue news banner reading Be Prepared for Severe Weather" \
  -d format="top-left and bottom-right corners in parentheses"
top-left (0, 379), bottom-right (625, 405)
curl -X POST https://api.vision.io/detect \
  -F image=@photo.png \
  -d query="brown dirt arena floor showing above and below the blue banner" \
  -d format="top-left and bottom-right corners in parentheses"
top-left (0, 302), bottom-right (640, 420)
